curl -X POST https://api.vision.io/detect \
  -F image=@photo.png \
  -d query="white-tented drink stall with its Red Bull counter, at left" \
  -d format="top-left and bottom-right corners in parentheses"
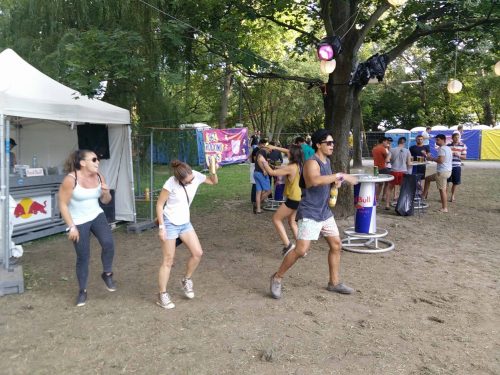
top-left (0, 49), bottom-right (135, 247)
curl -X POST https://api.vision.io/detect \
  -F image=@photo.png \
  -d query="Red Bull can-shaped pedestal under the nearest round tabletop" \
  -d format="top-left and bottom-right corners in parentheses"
top-left (354, 182), bottom-right (377, 234)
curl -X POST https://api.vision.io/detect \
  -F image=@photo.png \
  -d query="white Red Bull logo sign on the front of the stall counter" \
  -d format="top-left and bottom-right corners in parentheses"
top-left (12, 194), bottom-right (52, 225)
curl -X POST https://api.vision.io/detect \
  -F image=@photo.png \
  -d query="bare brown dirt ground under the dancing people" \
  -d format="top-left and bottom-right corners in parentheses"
top-left (0, 162), bottom-right (500, 375)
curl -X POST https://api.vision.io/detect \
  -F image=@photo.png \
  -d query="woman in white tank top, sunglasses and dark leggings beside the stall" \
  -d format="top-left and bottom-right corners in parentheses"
top-left (59, 150), bottom-right (116, 306)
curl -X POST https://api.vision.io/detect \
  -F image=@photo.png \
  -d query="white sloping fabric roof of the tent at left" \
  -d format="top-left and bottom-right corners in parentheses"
top-left (0, 49), bottom-right (130, 124)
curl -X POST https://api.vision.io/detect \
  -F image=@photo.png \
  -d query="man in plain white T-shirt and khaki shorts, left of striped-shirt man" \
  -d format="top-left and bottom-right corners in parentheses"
top-left (423, 134), bottom-right (453, 212)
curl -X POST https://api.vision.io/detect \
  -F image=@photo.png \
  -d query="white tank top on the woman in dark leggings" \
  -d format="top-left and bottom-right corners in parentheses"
top-left (68, 174), bottom-right (104, 225)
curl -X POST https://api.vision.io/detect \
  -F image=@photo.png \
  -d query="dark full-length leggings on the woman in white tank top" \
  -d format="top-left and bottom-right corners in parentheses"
top-left (74, 212), bottom-right (115, 290)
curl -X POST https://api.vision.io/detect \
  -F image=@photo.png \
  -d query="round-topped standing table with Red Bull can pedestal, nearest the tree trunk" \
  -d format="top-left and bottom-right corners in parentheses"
top-left (342, 174), bottom-right (394, 254)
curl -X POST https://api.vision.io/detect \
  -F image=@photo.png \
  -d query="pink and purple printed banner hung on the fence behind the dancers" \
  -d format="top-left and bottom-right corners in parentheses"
top-left (203, 128), bottom-right (248, 166)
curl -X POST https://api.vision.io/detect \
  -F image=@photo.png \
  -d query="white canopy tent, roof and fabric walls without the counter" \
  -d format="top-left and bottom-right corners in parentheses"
top-left (0, 49), bottom-right (135, 276)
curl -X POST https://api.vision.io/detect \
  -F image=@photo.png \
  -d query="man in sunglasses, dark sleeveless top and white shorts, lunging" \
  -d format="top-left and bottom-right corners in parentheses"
top-left (271, 129), bottom-right (358, 299)
